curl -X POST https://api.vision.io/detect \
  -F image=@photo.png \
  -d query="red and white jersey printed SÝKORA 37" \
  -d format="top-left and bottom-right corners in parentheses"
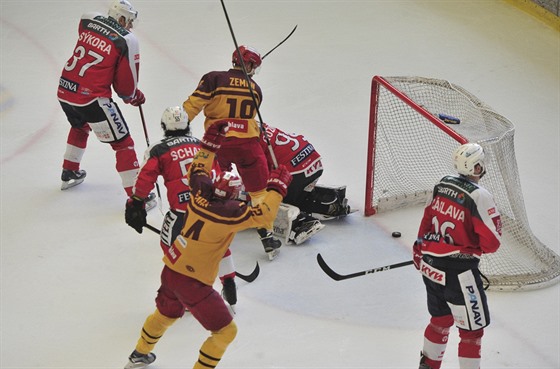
top-left (58, 13), bottom-right (140, 106)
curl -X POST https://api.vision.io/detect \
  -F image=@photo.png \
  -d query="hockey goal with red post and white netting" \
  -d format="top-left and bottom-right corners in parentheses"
top-left (364, 76), bottom-right (560, 290)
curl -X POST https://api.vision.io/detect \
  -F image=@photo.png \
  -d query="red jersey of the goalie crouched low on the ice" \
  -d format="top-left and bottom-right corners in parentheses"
top-left (261, 123), bottom-right (323, 177)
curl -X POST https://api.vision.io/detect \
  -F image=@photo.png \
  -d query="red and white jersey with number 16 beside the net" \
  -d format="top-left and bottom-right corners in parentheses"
top-left (418, 176), bottom-right (502, 257)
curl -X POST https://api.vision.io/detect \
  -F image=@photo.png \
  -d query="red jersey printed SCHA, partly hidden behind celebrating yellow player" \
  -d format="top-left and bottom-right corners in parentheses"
top-left (132, 136), bottom-right (220, 211)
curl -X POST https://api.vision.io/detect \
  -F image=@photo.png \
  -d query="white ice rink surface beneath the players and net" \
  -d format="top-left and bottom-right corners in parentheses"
top-left (0, 0), bottom-right (560, 369)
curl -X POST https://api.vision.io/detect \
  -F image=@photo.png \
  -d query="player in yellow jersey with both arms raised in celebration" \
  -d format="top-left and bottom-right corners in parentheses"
top-left (125, 120), bottom-right (292, 369)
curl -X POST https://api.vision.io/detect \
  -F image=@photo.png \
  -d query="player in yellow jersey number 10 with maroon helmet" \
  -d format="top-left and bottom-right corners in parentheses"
top-left (183, 45), bottom-right (282, 260)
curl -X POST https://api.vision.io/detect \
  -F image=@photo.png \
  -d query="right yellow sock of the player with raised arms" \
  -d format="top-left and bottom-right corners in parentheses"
top-left (193, 320), bottom-right (237, 369)
